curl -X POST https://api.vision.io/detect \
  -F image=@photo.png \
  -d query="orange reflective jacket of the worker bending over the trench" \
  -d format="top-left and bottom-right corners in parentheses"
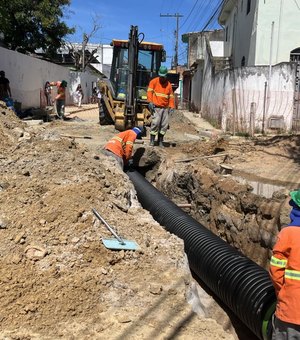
top-left (104, 130), bottom-right (137, 163)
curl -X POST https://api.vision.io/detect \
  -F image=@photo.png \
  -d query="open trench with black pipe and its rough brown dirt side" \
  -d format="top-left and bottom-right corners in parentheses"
top-left (127, 134), bottom-right (296, 339)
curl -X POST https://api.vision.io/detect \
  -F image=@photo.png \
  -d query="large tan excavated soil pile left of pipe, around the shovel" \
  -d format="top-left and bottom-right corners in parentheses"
top-left (0, 106), bottom-right (233, 339)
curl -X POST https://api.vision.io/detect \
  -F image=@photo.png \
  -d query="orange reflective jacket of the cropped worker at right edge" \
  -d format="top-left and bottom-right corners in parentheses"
top-left (269, 226), bottom-right (300, 325)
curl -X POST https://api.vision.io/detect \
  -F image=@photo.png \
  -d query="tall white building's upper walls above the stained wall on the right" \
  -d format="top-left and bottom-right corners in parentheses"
top-left (219, 0), bottom-right (300, 67)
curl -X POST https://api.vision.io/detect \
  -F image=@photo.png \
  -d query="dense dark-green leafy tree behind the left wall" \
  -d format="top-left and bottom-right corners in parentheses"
top-left (0, 0), bottom-right (75, 56)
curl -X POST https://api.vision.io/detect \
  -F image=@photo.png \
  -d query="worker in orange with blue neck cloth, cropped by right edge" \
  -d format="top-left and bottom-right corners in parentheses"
top-left (270, 190), bottom-right (300, 340)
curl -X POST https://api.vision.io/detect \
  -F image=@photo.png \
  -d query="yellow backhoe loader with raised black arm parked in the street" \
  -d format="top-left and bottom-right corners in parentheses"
top-left (98, 26), bottom-right (166, 131)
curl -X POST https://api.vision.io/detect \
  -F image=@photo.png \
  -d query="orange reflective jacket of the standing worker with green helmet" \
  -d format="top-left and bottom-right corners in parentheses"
top-left (147, 77), bottom-right (175, 109)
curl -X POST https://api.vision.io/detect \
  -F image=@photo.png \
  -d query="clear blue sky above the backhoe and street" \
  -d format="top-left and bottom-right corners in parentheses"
top-left (63, 0), bottom-right (222, 67)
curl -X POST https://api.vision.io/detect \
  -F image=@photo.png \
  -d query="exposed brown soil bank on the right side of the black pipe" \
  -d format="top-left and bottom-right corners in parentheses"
top-left (146, 136), bottom-right (299, 269)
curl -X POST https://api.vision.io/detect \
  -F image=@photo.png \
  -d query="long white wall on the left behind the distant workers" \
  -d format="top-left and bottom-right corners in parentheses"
top-left (0, 47), bottom-right (98, 109)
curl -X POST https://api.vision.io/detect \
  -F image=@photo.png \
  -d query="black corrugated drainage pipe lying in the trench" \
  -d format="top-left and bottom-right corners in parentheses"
top-left (127, 171), bottom-right (276, 339)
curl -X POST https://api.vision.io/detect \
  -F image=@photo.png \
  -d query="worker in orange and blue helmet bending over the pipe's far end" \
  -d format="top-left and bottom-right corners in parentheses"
top-left (103, 127), bottom-right (144, 169)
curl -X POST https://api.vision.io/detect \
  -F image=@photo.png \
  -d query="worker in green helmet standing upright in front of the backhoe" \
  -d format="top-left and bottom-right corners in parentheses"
top-left (147, 66), bottom-right (175, 146)
